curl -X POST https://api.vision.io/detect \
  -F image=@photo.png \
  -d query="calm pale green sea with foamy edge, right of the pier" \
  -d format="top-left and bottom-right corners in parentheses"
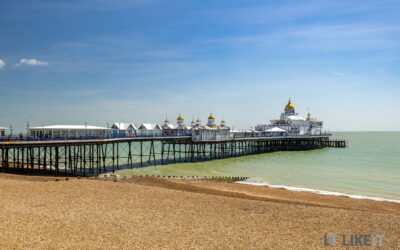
top-left (116, 132), bottom-right (400, 201)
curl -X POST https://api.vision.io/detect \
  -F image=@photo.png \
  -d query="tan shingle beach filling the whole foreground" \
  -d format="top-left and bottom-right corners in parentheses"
top-left (0, 174), bottom-right (400, 249)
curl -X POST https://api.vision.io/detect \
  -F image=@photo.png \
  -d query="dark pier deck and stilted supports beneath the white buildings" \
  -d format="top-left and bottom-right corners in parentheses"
top-left (0, 136), bottom-right (346, 176)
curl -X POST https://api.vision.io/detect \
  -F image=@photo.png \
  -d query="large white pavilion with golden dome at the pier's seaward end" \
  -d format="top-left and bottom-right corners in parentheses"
top-left (256, 99), bottom-right (322, 135)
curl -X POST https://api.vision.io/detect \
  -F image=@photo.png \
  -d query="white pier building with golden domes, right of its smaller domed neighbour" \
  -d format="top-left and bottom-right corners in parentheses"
top-left (191, 114), bottom-right (231, 141)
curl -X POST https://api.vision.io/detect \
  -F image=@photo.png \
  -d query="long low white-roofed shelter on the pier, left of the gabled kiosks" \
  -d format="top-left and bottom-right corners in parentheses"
top-left (28, 124), bottom-right (110, 139)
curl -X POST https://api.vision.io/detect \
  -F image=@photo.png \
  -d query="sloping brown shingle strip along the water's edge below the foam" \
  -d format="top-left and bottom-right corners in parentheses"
top-left (105, 176), bottom-right (400, 214)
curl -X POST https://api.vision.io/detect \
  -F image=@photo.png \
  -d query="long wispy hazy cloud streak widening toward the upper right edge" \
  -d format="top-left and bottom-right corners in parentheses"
top-left (202, 24), bottom-right (400, 51)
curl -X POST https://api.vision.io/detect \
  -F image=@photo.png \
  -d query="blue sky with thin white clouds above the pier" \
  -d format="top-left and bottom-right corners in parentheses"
top-left (0, 0), bottom-right (400, 131)
